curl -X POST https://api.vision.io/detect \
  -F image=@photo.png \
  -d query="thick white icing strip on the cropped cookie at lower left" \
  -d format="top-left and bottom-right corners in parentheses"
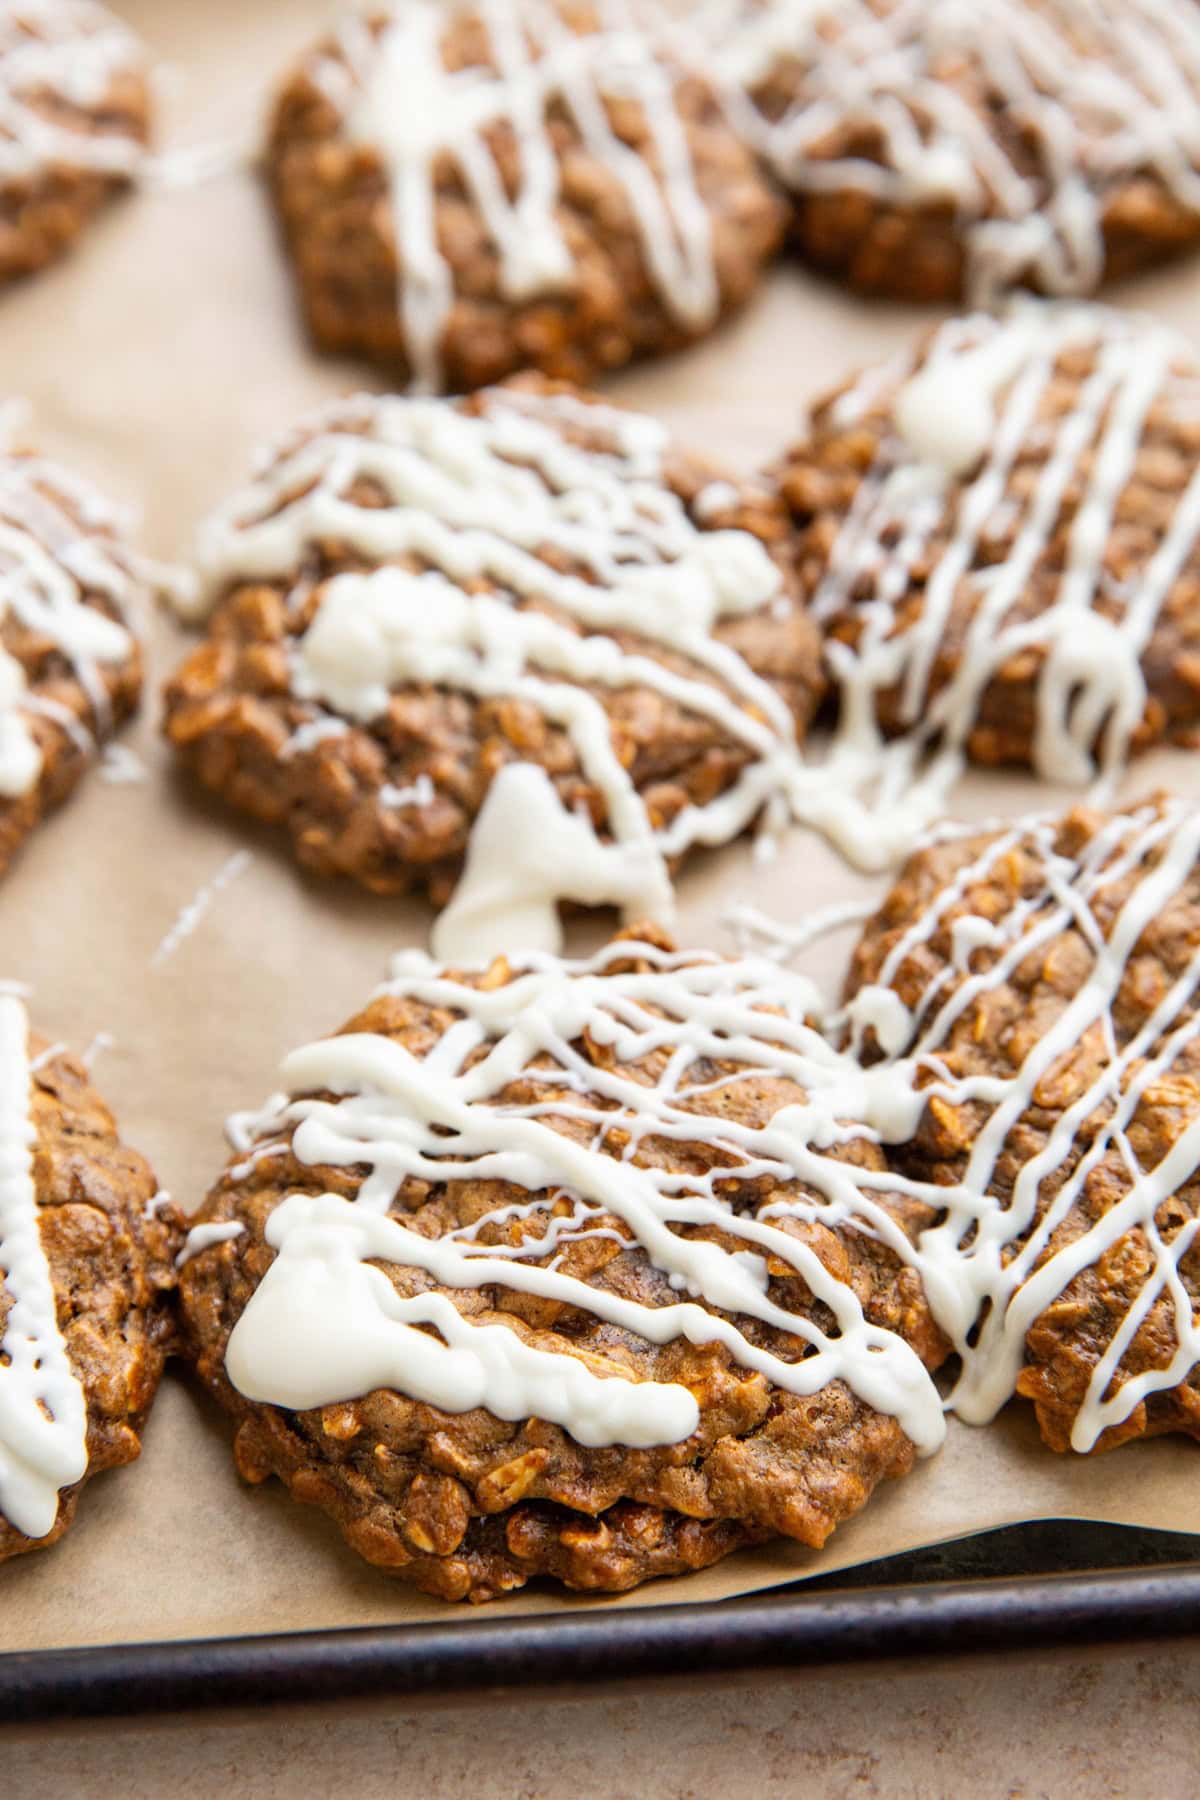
top-left (0, 994), bottom-right (88, 1537)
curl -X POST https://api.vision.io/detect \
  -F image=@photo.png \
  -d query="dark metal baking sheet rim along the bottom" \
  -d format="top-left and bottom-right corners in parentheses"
top-left (0, 1562), bottom-right (1200, 1724)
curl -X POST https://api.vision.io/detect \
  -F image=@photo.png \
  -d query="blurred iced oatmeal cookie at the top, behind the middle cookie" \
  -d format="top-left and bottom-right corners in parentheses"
top-left (266, 0), bottom-right (784, 392)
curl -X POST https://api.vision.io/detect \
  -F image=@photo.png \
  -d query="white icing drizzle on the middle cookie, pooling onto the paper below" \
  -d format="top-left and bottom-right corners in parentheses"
top-left (185, 389), bottom-right (797, 959)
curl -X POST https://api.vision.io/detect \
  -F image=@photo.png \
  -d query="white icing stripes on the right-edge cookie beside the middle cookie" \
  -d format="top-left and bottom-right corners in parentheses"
top-left (813, 301), bottom-right (1200, 851)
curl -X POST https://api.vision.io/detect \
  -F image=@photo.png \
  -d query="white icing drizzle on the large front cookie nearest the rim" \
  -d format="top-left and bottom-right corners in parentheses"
top-left (227, 943), bottom-right (945, 1451)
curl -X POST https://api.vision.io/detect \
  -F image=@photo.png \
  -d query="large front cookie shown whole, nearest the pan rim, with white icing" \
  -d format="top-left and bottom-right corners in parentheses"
top-left (180, 934), bottom-right (945, 1600)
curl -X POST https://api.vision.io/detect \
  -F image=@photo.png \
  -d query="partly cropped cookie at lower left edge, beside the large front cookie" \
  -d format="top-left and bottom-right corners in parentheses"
top-left (0, 994), bottom-right (178, 1562)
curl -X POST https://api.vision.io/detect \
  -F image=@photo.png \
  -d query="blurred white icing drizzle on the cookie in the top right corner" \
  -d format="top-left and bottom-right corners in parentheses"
top-left (703, 0), bottom-right (1200, 299)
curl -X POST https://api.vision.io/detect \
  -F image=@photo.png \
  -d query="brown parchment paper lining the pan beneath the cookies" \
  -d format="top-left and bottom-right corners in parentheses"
top-left (0, 0), bottom-right (1200, 1649)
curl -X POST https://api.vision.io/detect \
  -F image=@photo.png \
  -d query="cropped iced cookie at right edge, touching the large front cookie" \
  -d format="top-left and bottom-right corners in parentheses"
top-left (851, 796), bottom-right (1200, 1453)
